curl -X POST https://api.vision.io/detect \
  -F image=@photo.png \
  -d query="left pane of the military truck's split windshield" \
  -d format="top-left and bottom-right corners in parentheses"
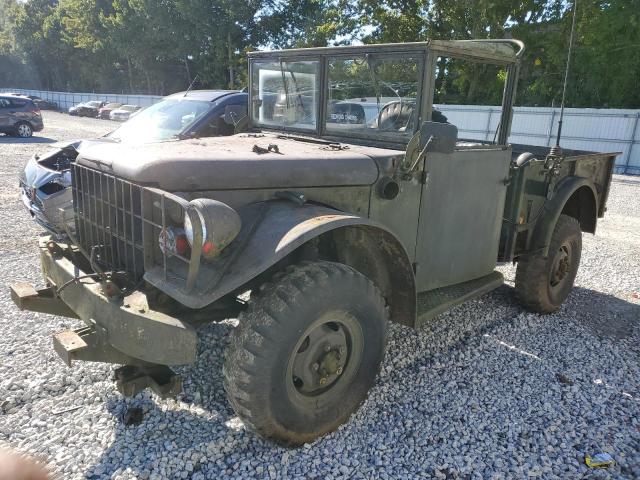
top-left (251, 61), bottom-right (319, 131)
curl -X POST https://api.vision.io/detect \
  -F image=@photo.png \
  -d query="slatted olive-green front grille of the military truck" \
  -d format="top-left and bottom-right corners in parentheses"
top-left (71, 164), bottom-right (144, 280)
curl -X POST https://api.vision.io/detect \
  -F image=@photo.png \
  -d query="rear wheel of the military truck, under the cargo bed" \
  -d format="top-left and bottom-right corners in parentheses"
top-left (515, 215), bottom-right (582, 313)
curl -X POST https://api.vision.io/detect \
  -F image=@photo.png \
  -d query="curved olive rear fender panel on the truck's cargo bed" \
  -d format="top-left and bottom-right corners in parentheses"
top-left (529, 177), bottom-right (598, 256)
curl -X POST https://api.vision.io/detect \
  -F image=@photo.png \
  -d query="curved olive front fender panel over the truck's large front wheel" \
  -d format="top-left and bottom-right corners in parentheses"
top-left (145, 201), bottom-right (415, 324)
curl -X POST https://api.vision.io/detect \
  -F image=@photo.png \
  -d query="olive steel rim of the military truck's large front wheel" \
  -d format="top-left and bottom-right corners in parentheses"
top-left (286, 311), bottom-right (364, 403)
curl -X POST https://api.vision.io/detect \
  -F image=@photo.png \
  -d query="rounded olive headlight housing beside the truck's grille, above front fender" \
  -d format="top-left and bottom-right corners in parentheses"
top-left (184, 198), bottom-right (242, 260)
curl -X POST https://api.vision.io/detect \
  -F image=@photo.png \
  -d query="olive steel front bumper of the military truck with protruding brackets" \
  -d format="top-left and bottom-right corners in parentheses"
top-left (12, 237), bottom-right (197, 365)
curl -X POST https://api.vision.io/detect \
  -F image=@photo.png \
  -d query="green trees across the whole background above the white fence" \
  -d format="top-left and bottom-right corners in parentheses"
top-left (0, 0), bottom-right (640, 108)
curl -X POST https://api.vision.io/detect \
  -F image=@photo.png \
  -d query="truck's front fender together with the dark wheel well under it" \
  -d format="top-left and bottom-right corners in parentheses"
top-left (145, 201), bottom-right (416, 326)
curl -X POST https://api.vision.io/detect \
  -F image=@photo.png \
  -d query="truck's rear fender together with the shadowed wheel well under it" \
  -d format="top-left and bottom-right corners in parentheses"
top-left (529, 177), bottom-right (598, 256)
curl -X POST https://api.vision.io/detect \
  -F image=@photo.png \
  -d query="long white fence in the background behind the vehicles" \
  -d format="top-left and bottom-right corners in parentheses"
top-left (0, 89), bottom-right (640, 175)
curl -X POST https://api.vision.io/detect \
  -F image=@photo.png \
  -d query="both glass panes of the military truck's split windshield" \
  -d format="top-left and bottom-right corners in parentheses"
top-left (251, 54), bottom-right (423, 143)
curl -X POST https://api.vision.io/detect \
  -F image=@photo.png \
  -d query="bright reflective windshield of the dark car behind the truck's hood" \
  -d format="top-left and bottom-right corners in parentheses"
top-left (108, 99), bottom-right (214, 143)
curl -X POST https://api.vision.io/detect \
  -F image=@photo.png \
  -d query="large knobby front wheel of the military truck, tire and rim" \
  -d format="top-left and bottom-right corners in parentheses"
top-left (223, 261), bottom-right (388, 446)
